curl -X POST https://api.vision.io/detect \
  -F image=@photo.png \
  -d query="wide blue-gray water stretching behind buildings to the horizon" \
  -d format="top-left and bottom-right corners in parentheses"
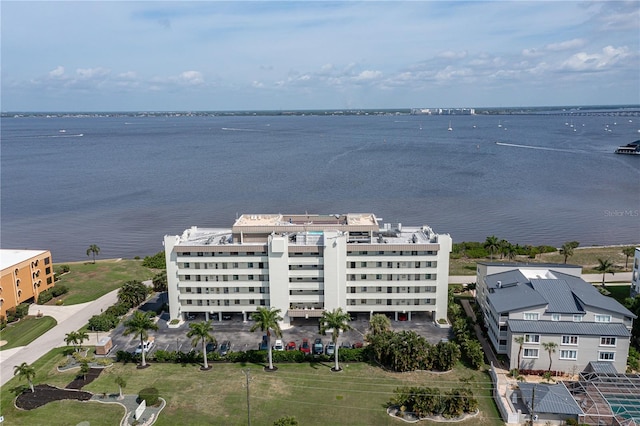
top-left (0, 115), bottom-right (640, 262)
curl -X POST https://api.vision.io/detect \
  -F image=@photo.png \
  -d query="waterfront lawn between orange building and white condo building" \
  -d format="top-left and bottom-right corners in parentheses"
top-left (53, 259), bottom-right (156, 305)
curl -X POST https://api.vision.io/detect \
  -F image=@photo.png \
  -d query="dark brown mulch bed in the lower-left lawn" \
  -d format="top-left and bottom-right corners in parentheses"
top-left (16, 368), bottom-right (103, 410)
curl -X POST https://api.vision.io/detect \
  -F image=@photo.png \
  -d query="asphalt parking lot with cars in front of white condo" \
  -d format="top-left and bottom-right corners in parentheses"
top-left (111, 295), bottom-right (451, 353)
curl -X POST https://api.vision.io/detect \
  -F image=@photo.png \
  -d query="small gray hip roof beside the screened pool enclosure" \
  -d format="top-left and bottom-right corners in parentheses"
top-left (518, 383), bottom-right (584, 415)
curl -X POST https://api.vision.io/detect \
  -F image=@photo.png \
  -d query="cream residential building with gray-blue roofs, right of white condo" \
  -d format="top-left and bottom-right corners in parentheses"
top-left (476, 262), bottom-right (636, 373)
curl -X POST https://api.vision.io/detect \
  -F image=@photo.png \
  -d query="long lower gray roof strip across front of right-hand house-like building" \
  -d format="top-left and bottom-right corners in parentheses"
top-left (508, 319), bottom-right (631, 337)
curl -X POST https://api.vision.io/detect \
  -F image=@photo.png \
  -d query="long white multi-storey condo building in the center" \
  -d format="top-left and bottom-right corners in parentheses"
top-left (164, 213), bottom-right (452, 325)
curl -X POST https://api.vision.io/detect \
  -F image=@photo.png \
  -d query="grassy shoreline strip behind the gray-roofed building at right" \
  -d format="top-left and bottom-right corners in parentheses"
top-left (449, 247), bottom-right (633, 277)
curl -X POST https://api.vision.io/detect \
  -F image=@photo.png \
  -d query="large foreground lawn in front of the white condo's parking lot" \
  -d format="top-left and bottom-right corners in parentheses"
top-left (1, 349), bottom-right (503, 426)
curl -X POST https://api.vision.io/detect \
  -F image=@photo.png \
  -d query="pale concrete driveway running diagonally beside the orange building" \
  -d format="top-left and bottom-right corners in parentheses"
top-left (0, 290), bottom-right (118, 386)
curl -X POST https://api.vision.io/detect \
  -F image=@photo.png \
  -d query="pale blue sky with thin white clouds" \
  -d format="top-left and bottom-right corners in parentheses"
top-left (0, 0), bottom-right (640, 112)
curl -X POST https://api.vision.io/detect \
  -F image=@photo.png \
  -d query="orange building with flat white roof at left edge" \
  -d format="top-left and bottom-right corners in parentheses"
top-left (0, 249), bottom-right (54, 318)
